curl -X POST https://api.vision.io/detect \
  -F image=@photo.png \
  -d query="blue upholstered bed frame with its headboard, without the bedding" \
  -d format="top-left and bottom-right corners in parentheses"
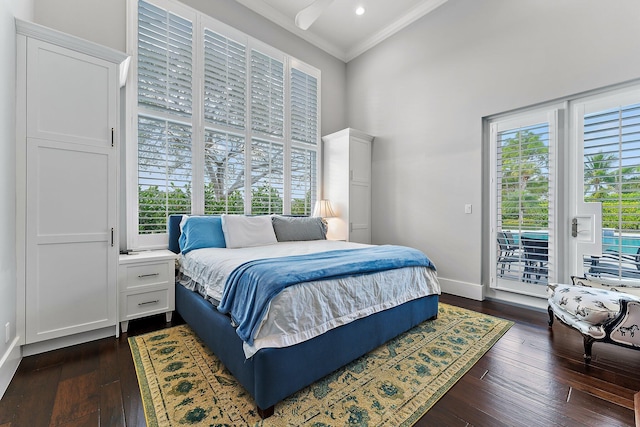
top-left (168, 215), bottom-right (438, 417)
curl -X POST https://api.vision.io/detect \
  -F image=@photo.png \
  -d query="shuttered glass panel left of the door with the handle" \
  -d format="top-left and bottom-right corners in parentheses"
top-left (491, 111), bottom-right (557, 295)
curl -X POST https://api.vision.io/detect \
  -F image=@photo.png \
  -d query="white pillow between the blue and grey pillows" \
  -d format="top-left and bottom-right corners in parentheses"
top-left (222, 215), bottom-right (278, 248)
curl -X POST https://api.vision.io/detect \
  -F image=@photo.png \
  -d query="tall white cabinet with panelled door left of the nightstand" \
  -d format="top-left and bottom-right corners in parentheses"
top-left (16, 21), bottom-right (128, 344)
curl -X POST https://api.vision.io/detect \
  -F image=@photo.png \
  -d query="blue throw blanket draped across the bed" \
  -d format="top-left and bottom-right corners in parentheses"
top-left (218, 245), bottom-right (435, 345)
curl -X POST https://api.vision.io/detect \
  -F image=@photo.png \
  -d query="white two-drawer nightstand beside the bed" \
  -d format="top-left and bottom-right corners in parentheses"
top-left (118, 250), bottom-right (177, 332)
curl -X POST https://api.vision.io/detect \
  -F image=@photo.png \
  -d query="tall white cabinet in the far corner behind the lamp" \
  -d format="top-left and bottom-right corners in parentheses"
top-left (322, 128), bottom-right (373, 243)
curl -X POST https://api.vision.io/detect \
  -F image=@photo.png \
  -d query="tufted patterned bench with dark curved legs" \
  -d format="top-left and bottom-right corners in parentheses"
top-left (547, 277), bottom-right (640, 364)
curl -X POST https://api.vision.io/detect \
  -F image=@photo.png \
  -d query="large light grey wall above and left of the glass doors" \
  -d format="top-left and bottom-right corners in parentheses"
top-left (347, 0), bottom-right (640, 297)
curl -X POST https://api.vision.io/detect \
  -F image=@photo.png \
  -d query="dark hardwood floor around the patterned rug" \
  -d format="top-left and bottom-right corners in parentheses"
top-left (0, 295), bottom-right (640, 427)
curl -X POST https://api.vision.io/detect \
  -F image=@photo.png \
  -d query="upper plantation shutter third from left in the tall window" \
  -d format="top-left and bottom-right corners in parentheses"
top-left (251, 50), bottom-right (284, 138)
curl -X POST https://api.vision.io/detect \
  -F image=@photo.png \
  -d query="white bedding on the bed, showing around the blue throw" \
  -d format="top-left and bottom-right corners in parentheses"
top-left (180, 240), bottom-right (440, 358)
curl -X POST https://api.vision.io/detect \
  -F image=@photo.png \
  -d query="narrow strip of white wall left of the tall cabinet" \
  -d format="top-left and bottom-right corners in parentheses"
top-left (0, 0), bottom-right (33, 397)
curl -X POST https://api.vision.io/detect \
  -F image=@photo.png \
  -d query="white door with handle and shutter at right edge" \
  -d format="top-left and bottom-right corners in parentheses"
top-left (569, 88), bottom-right (640, 281)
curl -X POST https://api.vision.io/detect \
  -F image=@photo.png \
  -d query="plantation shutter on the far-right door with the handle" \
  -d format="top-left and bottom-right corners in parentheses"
top-left (583, 104), bottom-right (640, 278)
